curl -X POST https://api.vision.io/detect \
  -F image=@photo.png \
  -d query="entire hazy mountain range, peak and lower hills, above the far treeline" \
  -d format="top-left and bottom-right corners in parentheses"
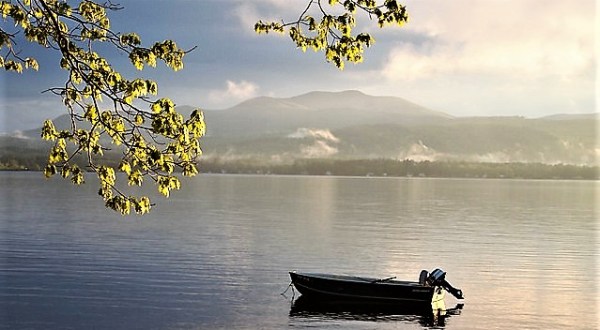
top-left (0, 91), bottom-right (600, 166)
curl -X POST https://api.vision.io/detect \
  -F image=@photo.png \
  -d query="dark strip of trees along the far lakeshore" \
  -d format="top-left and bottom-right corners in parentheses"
top-left (0, 156), bottom-right (600, 180)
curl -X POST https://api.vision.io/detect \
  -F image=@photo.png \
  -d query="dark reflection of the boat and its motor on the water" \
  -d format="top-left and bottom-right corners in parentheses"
top-left (290, 296), bottom-right (463, 327)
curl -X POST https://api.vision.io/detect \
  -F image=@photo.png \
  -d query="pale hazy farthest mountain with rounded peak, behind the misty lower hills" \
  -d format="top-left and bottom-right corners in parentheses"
top-left (199, 91), bottom-right (452, 137)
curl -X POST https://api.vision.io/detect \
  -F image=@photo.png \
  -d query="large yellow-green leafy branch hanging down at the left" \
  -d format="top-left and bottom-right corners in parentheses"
top-left (0, 0), bottom-right (205, 215)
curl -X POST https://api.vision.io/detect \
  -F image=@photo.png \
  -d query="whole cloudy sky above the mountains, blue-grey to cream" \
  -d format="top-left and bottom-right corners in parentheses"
top-left (0, 0), bottom-right (600, 132)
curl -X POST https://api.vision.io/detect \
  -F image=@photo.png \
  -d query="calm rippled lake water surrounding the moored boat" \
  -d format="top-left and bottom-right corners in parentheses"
top-left (0, 172), bottom-right (599, 329)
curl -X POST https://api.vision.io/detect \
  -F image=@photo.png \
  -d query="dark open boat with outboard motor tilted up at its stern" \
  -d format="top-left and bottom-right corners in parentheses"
top-left (289, 268), bottom-right (463, 303)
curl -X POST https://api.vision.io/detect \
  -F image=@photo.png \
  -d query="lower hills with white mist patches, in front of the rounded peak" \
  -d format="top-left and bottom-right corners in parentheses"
top-left (204, 118), bottom-right (600, 166)
